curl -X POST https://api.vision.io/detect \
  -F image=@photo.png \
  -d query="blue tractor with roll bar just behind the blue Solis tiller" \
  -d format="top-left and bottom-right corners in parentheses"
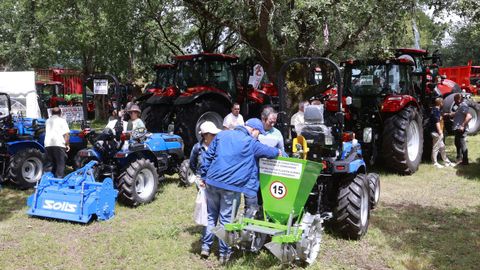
top-left (74, 74), bottom-right (184, 206)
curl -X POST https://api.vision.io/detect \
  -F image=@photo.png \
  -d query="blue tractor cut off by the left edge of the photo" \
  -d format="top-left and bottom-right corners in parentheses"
top-left (0, 93), bottom-right (86, 189)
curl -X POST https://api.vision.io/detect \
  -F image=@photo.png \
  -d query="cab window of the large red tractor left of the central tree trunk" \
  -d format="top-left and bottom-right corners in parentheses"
top-left (176, 61), bottom-right (235, 94)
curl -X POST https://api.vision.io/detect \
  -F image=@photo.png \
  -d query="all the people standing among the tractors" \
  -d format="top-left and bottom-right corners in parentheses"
top-left (41, 94), bottom-right (472, 263)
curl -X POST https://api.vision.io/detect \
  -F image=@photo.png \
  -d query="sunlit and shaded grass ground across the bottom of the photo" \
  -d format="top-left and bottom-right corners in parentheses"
top-left (0, 135), bottom-right (480, 269)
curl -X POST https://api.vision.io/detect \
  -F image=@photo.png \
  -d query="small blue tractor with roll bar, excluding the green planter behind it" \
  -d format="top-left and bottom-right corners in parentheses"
top-left (278, 58), bottom-right (380, 239)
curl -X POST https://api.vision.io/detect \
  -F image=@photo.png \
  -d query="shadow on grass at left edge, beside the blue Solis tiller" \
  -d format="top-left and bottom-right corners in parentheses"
top-left (0, 182), bottom-right (33, 222)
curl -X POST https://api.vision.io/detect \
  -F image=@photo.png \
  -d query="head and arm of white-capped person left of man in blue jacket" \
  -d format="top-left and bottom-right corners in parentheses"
top-left (190, 121), bottom-right (221, 177)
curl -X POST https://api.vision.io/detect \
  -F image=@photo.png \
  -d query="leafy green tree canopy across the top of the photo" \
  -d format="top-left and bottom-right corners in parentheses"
top-left (0, 0), bottom-right (480, 81)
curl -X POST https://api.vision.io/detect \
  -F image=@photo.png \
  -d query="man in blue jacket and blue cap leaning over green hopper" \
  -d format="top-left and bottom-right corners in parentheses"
top-left (200, 118), bottom-right (282, 264)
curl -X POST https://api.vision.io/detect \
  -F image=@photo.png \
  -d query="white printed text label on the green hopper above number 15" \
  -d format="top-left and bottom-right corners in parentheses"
top-left (260, 158), bottom-right (303, 179)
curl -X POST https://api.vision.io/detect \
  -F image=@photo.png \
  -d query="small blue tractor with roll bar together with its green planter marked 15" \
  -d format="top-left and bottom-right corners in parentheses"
top-left (214, 58), bottom-right (380, 264)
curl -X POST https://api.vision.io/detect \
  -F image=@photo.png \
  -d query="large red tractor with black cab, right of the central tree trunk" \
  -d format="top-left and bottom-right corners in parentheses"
top-left (334, 49), bottom-right (478, 174)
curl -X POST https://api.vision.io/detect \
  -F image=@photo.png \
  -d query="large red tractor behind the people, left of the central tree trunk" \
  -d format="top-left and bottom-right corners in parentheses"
top-left (141, 53), bottom-right (278, 154)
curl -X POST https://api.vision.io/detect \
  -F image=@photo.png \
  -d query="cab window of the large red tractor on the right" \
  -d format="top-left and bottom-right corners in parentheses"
top-left (346, 64), bottom-right (409, 96)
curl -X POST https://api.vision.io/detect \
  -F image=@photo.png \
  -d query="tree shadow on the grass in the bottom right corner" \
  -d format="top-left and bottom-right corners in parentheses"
top-left (373, 201), bottom-right (480, 269)
